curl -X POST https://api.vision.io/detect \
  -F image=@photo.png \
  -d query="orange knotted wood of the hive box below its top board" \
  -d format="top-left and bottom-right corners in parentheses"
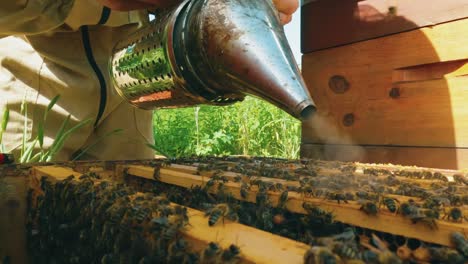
top-left (302, 19), bottom-right (468, 168)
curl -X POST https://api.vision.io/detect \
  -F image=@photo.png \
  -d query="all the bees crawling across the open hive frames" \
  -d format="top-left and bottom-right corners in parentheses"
top-left (28, 158), bottom-right (468, 264)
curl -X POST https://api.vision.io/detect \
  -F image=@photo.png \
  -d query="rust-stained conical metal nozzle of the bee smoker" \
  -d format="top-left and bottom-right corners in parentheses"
top-left (181, 0), bottom-right (315, 119)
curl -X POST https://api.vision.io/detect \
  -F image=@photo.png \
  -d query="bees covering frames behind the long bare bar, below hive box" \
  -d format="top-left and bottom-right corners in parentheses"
top-left (192, 158), bottom-right (468, 229)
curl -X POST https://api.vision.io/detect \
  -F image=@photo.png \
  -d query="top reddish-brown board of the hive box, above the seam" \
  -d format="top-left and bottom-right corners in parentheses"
top-left (301, 0), bottom-right (468, 53)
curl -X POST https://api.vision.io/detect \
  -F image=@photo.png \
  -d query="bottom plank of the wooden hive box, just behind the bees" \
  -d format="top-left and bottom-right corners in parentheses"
top-left (301, 143), bottom-right (468, 169)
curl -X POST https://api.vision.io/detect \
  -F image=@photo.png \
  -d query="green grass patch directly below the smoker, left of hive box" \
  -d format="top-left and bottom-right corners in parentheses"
top-left (152, 97), bottom-right (301, 158)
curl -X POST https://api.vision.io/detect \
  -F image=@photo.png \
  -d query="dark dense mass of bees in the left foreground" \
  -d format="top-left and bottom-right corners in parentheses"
top-left (28, 174), bottom-right (241, 264)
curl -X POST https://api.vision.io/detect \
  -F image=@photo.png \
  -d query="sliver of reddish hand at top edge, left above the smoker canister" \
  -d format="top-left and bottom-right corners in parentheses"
top-left (96, 0), bottom-right (182, 11)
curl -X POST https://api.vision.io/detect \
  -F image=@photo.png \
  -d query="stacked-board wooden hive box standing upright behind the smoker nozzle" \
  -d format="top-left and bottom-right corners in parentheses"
top-left (301, 0), bottom-right (468, 169)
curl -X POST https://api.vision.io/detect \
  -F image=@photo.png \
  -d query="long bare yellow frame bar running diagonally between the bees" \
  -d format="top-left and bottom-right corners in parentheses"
top-left (127, 166), bottom-right (468, 246)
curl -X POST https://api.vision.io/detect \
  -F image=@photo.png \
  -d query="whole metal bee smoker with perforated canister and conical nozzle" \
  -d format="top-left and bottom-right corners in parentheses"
top-left (110, 0), bottom-right (315, 119)
